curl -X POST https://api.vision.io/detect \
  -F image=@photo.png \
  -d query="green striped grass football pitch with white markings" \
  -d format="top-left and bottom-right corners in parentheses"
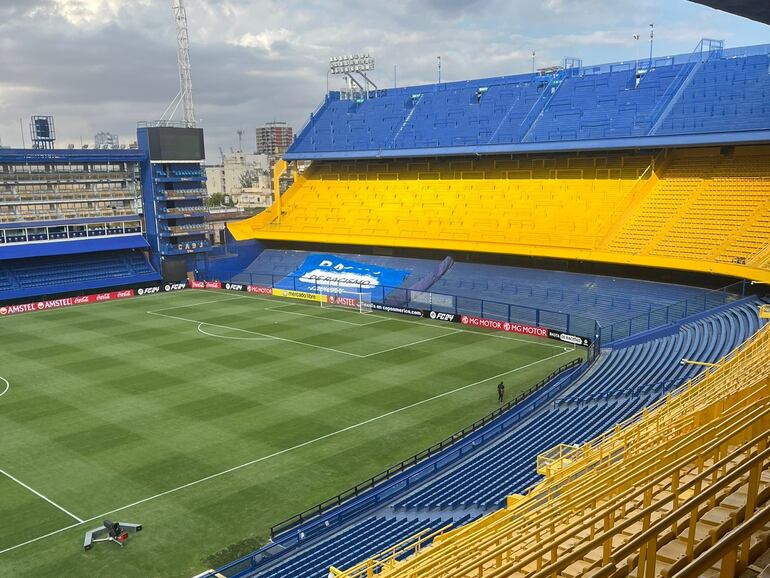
top-left (0, 291), bottom-right (582, 577)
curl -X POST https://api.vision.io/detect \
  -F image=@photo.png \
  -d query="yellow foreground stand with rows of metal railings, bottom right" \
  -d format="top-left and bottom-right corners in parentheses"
top-left (332, 325), bottom-right (770, 578)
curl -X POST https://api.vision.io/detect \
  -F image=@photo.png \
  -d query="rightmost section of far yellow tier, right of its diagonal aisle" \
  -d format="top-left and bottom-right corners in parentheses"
top-left (609, 148), bottom-right (770, 267)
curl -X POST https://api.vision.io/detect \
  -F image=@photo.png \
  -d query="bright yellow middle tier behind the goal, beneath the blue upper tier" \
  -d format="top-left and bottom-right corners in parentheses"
top-left (229, 147), bottom-right (770, 282)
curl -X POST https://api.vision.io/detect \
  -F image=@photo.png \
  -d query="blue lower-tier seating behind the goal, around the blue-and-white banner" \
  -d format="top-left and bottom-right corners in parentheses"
top-left (208, 249), bottom-right (720, 337)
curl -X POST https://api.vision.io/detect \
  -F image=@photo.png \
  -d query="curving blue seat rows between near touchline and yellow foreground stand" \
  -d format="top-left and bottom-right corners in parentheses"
top-left (219, 298), bottom-right (761, 578)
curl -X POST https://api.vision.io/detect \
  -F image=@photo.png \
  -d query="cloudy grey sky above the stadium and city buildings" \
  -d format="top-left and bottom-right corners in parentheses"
top-left (0, 0), bottom-right (770, 161)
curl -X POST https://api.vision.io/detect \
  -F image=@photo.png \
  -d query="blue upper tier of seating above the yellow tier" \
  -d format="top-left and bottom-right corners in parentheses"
top-left (284, 39), bottom-right (770, 160)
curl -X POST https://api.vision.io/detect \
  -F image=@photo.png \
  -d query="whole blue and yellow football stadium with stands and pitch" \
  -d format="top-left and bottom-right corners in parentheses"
top-left (0, 0), bottom-right (770, 578)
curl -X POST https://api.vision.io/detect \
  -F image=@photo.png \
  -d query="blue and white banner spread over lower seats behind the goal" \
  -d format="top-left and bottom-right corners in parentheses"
top-left (276, 254), bottom-right (409, 298)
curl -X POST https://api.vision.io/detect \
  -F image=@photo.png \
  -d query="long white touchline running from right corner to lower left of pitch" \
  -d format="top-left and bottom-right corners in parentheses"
top-left (0, 344), bottom-right (570, 555)
